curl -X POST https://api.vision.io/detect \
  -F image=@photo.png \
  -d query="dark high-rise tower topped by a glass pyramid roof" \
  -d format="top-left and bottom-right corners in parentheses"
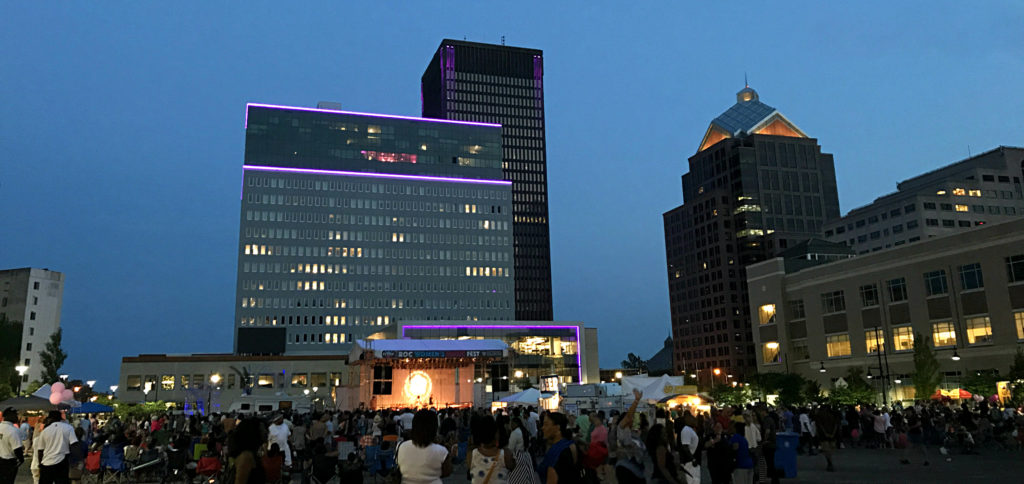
top-left (664, 86), bottom-right (839, 383)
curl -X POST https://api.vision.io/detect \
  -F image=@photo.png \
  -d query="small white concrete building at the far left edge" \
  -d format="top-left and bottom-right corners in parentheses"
top-left (0, 267), bottom-right (65, 387)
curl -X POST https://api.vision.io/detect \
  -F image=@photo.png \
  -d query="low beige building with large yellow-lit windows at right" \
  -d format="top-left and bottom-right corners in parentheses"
top-left (746, 216), bottom-right (1024, 399)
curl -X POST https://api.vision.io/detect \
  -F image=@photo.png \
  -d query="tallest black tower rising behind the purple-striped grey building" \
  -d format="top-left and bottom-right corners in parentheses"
top-left (421, 39), bottom-right (554, 321)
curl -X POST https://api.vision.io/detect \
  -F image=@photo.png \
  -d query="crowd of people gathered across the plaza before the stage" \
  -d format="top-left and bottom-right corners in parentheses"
top-left (0, 391), bottom-right (1024, 484)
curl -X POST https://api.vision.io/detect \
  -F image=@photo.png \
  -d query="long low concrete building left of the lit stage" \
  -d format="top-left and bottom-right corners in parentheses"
top-left (115, 354), bottom-right (353, 413)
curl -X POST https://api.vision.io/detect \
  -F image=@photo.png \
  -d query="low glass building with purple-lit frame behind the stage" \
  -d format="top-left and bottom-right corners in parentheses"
top-left (397, 321), bottom-right (600, 384)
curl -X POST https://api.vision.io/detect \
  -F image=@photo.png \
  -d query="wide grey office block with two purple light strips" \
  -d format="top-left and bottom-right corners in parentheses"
top-left (234, 104), bottom-right (515, 354)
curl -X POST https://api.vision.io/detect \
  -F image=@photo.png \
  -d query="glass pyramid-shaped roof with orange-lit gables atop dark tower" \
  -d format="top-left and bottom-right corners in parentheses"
top-left (697, 86), bottom-right (808, 151)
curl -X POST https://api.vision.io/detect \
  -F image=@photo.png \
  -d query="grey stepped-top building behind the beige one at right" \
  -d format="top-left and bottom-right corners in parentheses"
top-left (824, 146), bottom-right (1024, 254)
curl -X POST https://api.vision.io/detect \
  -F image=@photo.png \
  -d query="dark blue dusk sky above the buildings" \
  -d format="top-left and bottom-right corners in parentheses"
top-left (0, 1), bottom-right (1024, 387)
